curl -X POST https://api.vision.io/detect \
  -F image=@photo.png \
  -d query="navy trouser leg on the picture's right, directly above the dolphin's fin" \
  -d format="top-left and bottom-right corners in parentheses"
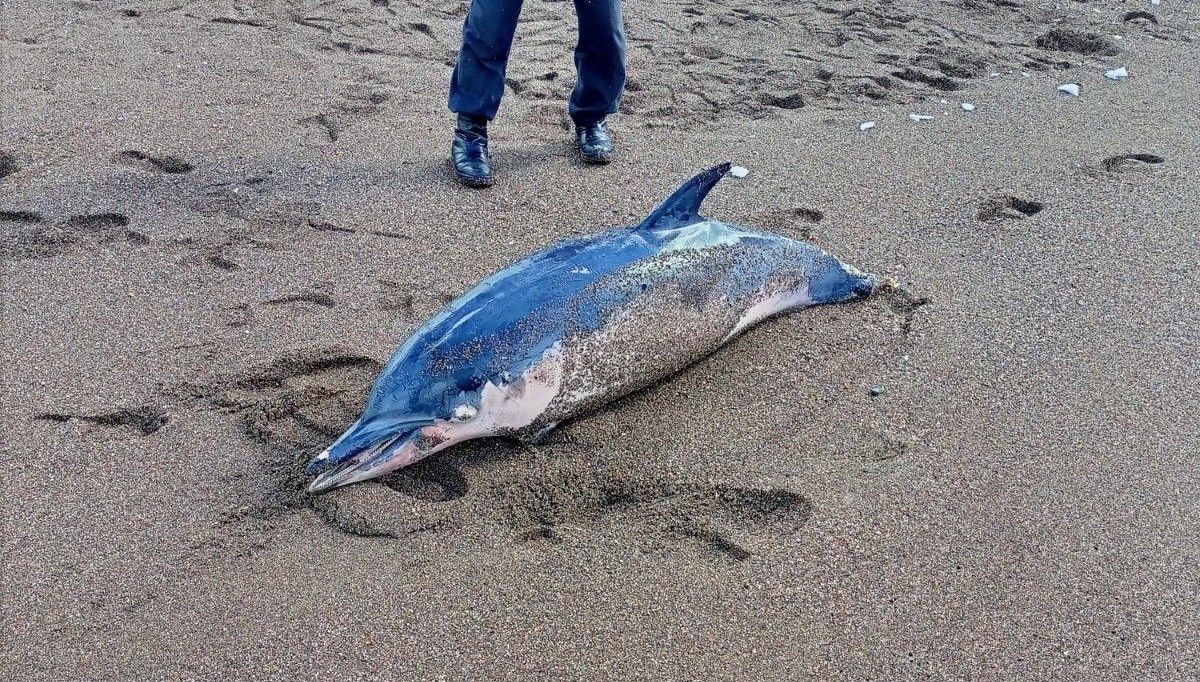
top-left (568, 0), bottom-right (625, 125)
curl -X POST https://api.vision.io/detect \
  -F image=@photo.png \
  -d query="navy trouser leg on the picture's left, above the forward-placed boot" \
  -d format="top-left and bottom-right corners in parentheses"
top-left (450, 0), bottom-right (521, 120)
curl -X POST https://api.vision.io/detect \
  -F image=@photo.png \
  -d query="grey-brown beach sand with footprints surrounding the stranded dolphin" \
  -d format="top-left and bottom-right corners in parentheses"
top-left (0, 0), bottom-right (1200, 681)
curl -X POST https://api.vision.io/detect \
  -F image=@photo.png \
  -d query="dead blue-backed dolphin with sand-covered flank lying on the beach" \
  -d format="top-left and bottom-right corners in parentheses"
top-left (308, 163), bottom-right (882, 492)
